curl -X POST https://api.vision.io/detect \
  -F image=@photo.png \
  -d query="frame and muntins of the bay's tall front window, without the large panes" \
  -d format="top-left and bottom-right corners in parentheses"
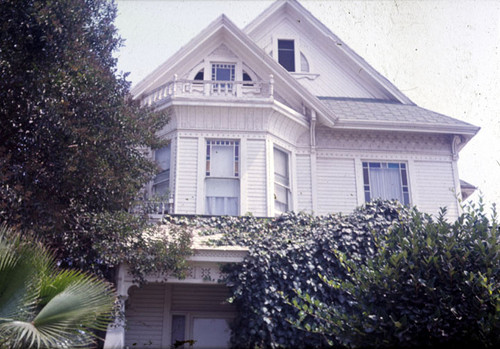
top-left (204, 139), bottom-right (241, 216)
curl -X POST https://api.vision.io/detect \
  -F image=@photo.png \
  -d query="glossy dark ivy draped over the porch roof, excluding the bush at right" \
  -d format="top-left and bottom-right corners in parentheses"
top-left (166, 202), bottom-right (410, 348)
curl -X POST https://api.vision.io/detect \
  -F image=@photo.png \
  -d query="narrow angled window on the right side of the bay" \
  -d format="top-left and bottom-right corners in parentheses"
top-left (274, 148), bottom-right (292, 214)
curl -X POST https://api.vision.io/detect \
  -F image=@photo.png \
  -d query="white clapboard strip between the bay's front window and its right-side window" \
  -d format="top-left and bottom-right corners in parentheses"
top-left (242, 139), bottom-right (267, 216)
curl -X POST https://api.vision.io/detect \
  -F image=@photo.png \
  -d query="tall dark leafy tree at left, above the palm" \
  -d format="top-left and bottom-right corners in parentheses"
top-left (0, 0), bottom-right (189, 277)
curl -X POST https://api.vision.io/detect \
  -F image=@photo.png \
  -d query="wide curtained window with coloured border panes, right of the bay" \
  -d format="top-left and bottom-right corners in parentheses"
top-left (363, 162), bottom-right (410, 205)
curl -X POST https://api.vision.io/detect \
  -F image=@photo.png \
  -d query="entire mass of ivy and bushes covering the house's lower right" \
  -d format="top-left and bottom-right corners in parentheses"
top-left (170, 201), bottom-right (500, 348)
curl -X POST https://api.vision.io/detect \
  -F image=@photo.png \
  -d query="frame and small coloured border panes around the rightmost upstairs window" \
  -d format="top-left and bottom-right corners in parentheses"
top-left (361, 160), bottom-right (412, 205)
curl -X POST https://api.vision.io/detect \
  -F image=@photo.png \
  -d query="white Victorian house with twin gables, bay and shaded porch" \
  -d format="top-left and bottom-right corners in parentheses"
top-left (105, 0), bottom-right (479, 348)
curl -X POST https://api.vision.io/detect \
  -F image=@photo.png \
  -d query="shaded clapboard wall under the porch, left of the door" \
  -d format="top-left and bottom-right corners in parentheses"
top-left (125, 284), bottom-right (165, 348)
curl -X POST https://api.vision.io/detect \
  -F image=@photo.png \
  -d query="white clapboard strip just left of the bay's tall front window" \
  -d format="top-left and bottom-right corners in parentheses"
top-left (175, 137), bottom-right (198, 214)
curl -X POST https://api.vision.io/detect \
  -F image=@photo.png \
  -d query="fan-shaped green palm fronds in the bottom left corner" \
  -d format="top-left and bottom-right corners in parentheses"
top-left (0, 225), bottom-right (114, 348)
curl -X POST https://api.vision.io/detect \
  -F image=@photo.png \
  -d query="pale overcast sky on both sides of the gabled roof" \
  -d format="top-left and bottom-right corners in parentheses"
top-left (115, 0), bottom-right (500, 211)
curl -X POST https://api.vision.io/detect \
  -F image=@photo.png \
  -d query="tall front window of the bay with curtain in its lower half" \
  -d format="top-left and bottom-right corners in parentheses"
top-left (205, 140), bottom-right (240, 216)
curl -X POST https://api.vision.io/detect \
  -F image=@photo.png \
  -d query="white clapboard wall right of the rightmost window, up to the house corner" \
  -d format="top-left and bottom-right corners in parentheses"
top-left (409, 161), bottom-right (458, 219)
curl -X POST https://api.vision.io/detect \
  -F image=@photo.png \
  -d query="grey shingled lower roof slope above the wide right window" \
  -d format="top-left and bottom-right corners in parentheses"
top-left (318, 97), bottom-right (479, 137)
